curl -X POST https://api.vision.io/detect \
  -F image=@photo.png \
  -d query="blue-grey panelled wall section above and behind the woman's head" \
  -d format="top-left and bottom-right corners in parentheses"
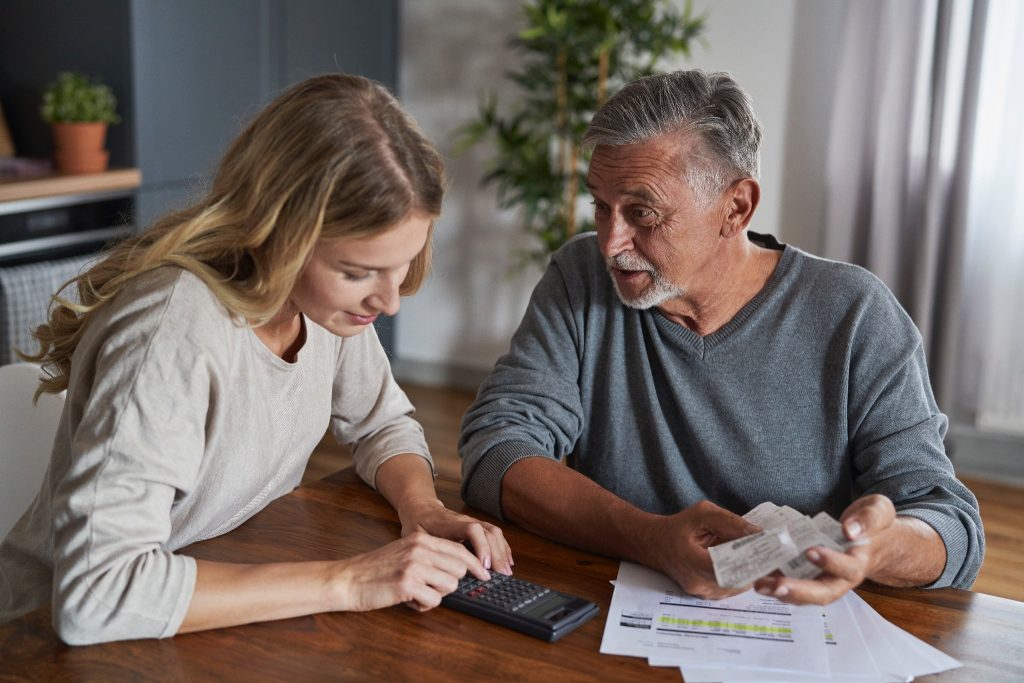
top-left (131, 0), bottom-right (398, 224)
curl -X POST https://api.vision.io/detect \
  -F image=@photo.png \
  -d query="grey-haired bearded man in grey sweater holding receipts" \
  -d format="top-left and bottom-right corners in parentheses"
top-left (460, 71), bottom-right (984, 604)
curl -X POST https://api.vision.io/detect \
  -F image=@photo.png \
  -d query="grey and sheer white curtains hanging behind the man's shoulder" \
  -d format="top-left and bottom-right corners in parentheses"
top-left (824, 0), bottom-right (1024, 436)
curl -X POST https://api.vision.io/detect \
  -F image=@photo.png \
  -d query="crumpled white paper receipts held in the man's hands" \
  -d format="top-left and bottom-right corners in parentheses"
top-left (708, 501), bottom-right (866, 588)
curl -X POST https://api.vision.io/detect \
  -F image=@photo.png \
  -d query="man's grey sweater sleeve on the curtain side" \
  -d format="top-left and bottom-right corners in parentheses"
top-left (849, 286), bottom-right (985, 589)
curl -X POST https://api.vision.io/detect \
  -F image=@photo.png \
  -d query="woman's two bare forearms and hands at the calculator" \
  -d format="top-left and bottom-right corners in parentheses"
top-left (178, 454), bottom-right (511, 633)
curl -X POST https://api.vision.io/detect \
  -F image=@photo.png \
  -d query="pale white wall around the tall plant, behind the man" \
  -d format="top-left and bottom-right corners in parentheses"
top-left (395, 0), bottom-right (842, 384)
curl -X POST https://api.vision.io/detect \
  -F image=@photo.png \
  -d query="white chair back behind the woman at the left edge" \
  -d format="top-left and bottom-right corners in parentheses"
top-left (0, 362), bottom-right (65, 540)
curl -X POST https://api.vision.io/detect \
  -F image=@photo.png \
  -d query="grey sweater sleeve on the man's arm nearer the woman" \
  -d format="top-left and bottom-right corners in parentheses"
top-left (459, 255), bottom-right (584, 516)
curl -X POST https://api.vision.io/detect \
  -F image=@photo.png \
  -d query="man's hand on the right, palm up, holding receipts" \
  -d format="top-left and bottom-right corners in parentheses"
top-left (754, 495), bottom-right (901, 605)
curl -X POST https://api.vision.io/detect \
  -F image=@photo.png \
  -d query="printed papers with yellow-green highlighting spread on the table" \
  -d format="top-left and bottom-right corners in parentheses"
top-left (601, 562), bottom-right (961, 683)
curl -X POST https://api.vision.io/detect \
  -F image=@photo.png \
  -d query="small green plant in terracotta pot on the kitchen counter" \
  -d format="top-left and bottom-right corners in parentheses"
top-left (39, 72), bottom-right (121, 173)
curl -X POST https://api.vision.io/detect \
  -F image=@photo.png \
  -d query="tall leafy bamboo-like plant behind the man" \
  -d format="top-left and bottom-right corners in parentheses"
top-left (457, 0), bottom-right (705, 265)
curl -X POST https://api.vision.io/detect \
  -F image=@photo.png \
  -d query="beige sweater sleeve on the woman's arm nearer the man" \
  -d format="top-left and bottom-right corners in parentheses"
top-left (331, 327), bottom-right (436, 487)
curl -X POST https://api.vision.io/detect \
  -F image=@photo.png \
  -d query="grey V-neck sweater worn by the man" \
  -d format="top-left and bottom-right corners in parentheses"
top-left (460, 233), bottom-right (984, 588)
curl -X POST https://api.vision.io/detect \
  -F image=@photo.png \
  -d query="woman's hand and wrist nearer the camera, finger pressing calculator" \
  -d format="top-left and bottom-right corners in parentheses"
top-left (329, 531), bottom-right (490, 611)
